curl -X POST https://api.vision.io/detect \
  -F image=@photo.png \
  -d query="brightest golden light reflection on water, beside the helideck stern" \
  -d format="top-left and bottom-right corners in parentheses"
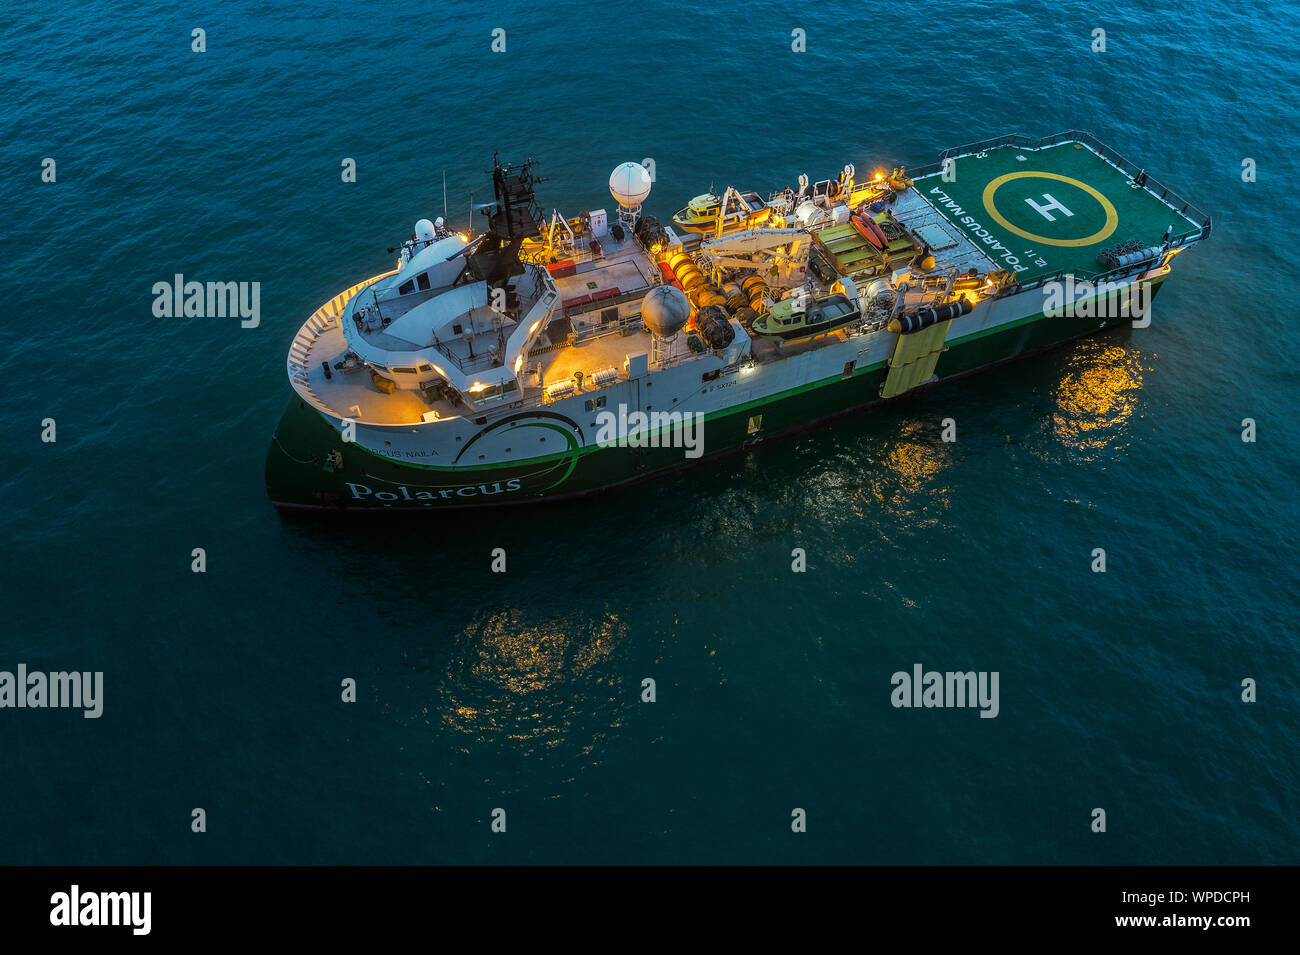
top-left (1052, 343), bottom-right (1141, 461)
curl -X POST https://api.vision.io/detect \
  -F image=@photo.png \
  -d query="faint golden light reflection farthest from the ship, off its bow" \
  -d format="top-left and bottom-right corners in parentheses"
top-left (441, 608), bottom-right (636, 755)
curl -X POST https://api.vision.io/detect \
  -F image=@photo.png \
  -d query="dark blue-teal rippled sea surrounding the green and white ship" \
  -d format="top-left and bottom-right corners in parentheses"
top-left (0, 0), bottom-right (1300, 864)
